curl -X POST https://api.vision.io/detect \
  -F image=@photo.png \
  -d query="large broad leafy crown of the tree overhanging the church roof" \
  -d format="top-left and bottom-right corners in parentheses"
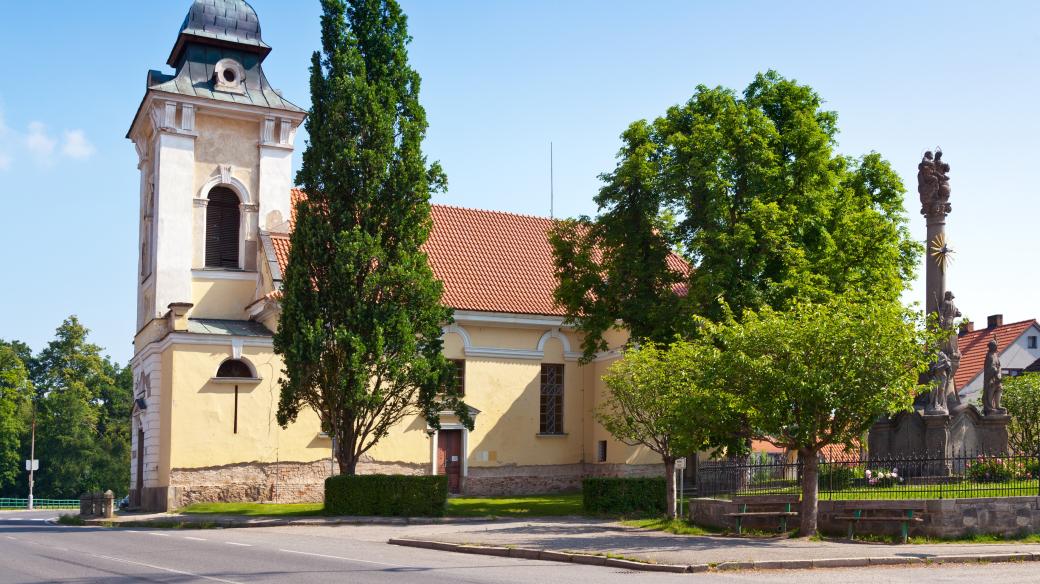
top-left (553, 71), bottom-right (921, 340)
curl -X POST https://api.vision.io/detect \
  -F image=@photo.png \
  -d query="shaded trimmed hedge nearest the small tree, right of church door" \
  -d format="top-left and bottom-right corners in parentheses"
top-left (581, 477), bottom-right (668, 514)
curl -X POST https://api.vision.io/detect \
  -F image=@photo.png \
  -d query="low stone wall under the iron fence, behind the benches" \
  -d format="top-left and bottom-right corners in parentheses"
top-left (690, 497), bottom-right (1040, 538)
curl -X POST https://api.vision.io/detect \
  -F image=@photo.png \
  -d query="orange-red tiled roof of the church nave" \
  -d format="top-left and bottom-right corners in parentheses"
top-left (271, 188), bottom-right (688, 316)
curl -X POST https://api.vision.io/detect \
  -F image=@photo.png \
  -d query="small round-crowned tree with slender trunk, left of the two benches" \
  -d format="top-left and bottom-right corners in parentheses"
top-left (595, 341), bottom-right (735, 517)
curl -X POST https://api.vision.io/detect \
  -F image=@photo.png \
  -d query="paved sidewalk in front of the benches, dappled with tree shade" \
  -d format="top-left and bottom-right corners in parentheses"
top-left (393, 520), bottom-right (1040, 565)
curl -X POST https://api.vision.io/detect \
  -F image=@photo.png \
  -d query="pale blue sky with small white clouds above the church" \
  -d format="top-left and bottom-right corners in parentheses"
top-left (0, 0), bottom-right (1040, 362)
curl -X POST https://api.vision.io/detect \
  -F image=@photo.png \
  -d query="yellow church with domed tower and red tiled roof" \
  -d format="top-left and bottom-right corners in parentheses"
top-left (127, 0), bottom-right (662, 510)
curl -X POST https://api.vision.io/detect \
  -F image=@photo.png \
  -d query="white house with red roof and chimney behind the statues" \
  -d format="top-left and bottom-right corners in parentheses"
top-left (954, 314), bottom-right (1040, 404)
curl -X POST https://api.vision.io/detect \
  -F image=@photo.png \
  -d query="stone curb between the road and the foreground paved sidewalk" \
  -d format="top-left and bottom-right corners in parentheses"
top-left (387, 538), bottom-right (1040, 574)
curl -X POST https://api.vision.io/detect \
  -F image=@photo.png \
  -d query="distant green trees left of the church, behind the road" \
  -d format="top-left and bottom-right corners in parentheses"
top-left (0, 316), bottom-right (133, 499)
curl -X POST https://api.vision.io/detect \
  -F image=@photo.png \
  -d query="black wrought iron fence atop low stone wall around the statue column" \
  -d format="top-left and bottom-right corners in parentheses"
top-left (694, 446), bottom-right (1040, 500)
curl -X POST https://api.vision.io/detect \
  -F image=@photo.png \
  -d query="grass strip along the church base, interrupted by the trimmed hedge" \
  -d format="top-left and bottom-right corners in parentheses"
top-left (177, 494), bottom-right (583, 517)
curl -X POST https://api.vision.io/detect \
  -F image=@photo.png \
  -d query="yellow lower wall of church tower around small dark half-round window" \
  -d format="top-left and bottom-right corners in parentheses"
top-left (166, 340), bottom-right (332, 469)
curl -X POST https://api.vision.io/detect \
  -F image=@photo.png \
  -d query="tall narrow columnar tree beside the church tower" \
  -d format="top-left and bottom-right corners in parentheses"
top-left (275, 0), bottom-right (472, 474)
